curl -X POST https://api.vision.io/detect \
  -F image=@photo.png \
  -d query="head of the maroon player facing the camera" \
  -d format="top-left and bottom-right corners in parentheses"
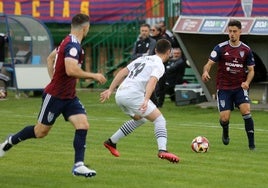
top-left (228, 20), bottom-right (242, 43)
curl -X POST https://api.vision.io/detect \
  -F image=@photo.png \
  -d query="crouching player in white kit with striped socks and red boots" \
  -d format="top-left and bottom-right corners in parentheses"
top-left (100, 39), bottom-right (179, 162)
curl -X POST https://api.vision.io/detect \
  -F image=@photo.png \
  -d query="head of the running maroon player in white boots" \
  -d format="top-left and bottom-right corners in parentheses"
top-left (71, 14), bottom-right (90, 37)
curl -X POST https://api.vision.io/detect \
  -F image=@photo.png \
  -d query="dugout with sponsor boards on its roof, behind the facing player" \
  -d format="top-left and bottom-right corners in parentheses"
top-left (172, 16), bottom-right (268, 101)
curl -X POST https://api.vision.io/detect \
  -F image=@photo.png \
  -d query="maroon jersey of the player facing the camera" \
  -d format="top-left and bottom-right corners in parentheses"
top-left (209, 41), bottom-right (255, 90)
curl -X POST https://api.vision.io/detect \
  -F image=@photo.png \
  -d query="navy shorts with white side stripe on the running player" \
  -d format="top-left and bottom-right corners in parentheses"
top-left (38, 93), bottom-right (86, 125)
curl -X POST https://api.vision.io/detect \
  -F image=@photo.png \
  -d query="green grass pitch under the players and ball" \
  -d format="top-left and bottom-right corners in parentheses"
top-left (0, 91), bottom-right (268, 188)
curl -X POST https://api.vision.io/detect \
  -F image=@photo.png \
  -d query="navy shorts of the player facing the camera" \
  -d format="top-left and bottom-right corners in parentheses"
top-left (217, 88), bottom-right (250, 112)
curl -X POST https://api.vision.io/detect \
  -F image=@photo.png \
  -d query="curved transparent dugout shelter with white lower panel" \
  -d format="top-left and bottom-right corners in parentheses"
top-left (0, 14), bottom-right (53, 90)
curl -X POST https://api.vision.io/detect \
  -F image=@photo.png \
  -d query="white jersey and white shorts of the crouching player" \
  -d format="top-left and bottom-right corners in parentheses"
top-left (115, 55), bottom-right (165, 117)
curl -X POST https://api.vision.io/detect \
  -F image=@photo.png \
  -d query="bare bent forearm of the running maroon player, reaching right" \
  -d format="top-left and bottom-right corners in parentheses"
top-left (64, 57), bottom-right (106, 84)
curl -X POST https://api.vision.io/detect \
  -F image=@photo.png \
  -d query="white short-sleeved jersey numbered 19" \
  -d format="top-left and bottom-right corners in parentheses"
top-left (120, 55), bottom-right (165, 94)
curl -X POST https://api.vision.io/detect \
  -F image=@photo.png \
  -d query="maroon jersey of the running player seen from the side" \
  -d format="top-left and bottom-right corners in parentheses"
top-left (45, 35), bottom-right (84, 99)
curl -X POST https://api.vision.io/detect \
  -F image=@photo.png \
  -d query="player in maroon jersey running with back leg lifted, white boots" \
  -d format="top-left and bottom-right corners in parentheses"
top-left (0, 14), bottom-right (106, 177)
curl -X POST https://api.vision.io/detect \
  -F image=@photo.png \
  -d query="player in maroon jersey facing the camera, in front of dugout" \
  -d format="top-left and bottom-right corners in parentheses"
top-left (202, 20), bottom-right (255, 150)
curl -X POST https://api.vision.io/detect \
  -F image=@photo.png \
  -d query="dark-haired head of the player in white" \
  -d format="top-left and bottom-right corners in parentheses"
top-left (155, 39), bottom-right (171, 62)
